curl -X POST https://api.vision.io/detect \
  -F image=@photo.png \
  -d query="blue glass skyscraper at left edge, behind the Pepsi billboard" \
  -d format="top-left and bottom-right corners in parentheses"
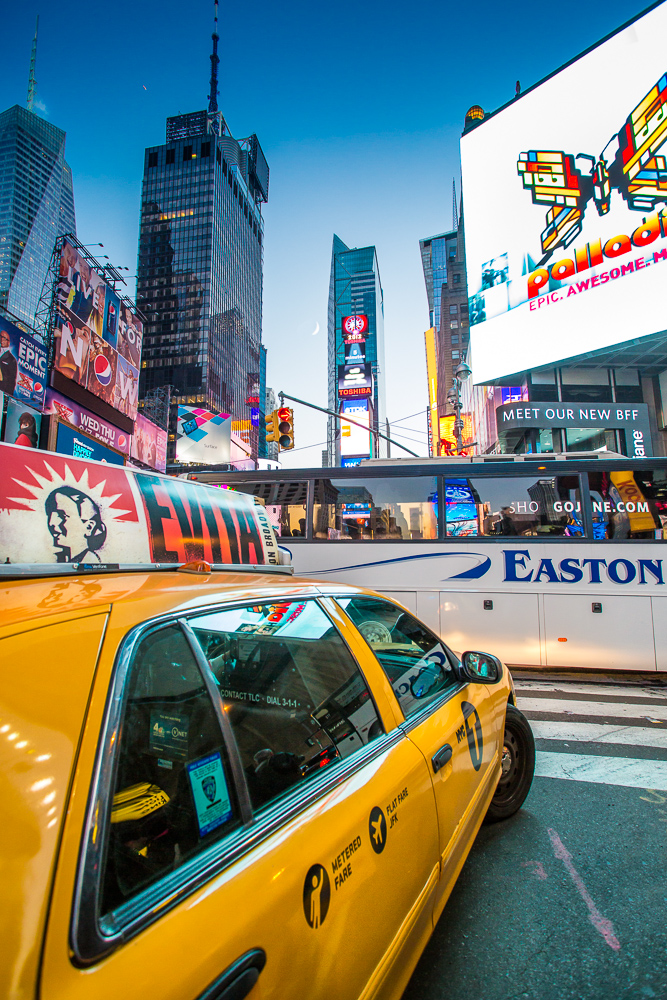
top-left (0, 104), bottom-right (76, 325)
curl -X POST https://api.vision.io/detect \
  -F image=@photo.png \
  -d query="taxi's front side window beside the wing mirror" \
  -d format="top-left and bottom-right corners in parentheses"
top-left (337, 595), bottom-right (458, 718)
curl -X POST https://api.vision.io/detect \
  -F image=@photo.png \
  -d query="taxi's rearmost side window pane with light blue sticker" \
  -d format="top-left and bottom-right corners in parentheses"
top-left (102, 626), bottom-right (239, 913)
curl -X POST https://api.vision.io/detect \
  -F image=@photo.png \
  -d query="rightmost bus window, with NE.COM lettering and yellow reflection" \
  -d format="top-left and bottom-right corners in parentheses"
top-left (588, 469), bottom-right (667, 539)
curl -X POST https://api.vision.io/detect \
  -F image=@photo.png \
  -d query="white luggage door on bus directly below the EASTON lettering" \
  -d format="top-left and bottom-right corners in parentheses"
top-left (544, 594), bottom-right (656, 670)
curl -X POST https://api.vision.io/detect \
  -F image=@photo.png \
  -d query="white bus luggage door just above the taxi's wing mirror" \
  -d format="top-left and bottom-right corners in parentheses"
top-left (440, 591), bottom-right (541, 664)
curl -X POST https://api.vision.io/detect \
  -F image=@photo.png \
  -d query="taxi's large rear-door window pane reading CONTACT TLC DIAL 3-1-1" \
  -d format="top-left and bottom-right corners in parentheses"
top-left (190, 600), bottom-right (384, 810)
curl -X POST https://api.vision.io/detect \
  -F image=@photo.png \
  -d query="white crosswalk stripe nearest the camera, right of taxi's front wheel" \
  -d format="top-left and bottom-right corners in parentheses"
top-left (535, 750), bottom-right (667, 791)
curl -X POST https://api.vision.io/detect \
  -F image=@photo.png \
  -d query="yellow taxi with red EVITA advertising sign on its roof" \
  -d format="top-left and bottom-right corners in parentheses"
top-left (0, 446), bottom-right (534, 1000)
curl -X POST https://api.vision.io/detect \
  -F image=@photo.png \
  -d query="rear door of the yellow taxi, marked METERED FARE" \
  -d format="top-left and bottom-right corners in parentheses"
top-left (41, 601), bottom-right (439, 1000)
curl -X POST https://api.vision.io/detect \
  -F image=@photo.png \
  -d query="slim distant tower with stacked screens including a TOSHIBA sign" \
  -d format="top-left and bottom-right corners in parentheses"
top-left (327, 236), bottom-right (387, 466)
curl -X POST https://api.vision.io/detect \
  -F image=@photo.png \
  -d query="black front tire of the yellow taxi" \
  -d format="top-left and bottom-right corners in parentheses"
top-left (484, 705), bottom-right (535, 823)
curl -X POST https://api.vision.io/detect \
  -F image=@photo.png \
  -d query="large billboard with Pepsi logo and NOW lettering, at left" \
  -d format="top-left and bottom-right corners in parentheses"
top-left (53, 240), bottom-right (143, 420)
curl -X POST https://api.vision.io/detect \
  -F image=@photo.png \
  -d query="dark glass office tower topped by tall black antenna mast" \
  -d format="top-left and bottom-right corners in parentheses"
top-left (137, 5), bottom-right (269, 462)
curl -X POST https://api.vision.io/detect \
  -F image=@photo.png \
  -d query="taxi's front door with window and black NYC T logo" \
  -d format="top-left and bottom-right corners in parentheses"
top-left (338, 595), bottom-right (506, 918)
